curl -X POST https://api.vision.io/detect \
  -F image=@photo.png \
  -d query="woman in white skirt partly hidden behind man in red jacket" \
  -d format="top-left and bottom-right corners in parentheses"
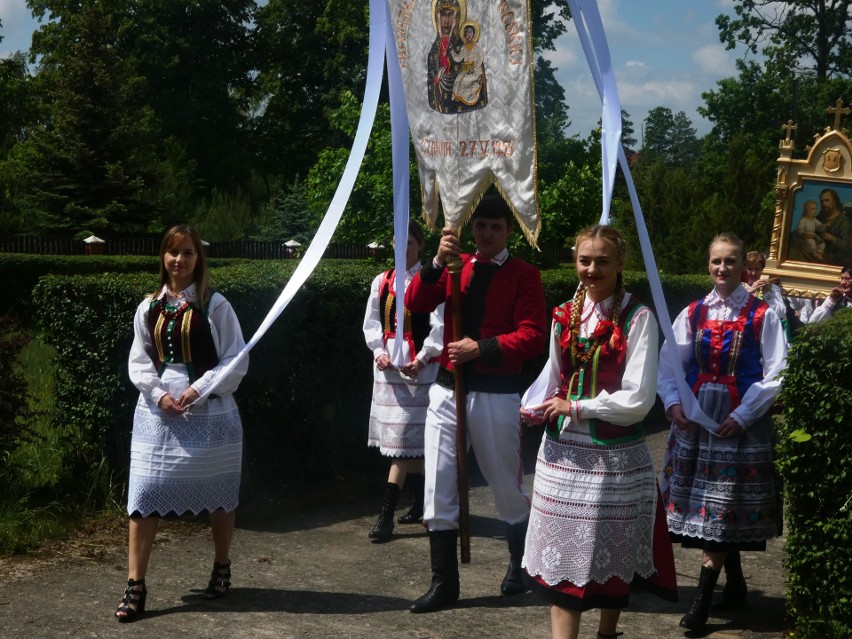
top-left (364, 222), bottom-right (444, 541)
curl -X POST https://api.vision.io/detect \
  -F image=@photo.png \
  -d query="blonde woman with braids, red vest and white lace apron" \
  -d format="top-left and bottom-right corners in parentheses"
top-left (521, 225), bottom-right (677, 639)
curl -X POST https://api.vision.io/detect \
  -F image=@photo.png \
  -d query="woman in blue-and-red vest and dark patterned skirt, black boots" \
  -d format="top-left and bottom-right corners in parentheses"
top-left (657, 233), bottom-right (787, 631)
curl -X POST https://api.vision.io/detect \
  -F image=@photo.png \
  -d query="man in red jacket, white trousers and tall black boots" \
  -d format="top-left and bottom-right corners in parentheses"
top-left (406, 194), bottom-right (547, 613)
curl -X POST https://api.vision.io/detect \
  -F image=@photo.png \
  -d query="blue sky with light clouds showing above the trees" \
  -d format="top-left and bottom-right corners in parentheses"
top-left (0, 0), bottom-right (738, 142)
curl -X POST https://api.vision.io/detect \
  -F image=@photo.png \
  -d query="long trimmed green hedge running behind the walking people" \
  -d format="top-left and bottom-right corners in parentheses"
top-left (34, 258), bottom-right (709, 496)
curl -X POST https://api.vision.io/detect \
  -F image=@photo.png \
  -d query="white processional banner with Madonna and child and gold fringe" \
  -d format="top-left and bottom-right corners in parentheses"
top-left (388, 0), bottom-right (541, 244)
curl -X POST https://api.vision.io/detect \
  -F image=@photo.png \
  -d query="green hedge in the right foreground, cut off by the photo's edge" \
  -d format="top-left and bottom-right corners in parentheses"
top-left (777, 310), bottom-right (852, 639)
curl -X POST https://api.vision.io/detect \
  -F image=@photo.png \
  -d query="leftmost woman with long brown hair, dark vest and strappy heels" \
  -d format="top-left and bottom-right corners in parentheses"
top-left (115, 226), bottom-right (248, 622)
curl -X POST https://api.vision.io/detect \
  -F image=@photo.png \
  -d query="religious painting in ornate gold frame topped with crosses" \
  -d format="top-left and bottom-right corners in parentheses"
top-left (764, 100), bottom-right (852, 299)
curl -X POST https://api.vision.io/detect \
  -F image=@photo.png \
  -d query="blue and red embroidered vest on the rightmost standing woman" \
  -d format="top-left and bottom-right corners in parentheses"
top-left (686, 295), bottom-right (769, 410)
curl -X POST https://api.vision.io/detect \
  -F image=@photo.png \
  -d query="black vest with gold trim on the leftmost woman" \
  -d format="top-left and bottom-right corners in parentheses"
top-left (148, 296), bottom-right (219, 384)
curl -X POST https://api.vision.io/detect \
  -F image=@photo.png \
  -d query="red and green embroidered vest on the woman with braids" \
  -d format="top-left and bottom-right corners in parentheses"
top-left (545, 295), bottom-right (645, 445)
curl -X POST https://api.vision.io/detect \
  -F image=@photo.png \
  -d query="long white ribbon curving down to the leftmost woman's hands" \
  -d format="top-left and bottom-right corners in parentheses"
top-left (195, 0), bottom-right (390, 403)
